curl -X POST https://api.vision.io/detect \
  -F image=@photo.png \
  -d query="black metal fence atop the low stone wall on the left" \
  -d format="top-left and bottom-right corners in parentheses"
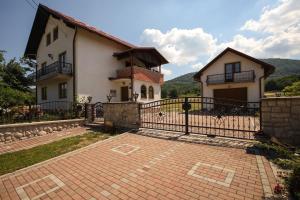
top-left (0, 101), bottom-right (85, 124)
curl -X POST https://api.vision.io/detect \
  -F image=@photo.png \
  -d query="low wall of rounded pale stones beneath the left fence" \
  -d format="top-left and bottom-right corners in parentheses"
top-left (0, 119), bottom-right (84, 144)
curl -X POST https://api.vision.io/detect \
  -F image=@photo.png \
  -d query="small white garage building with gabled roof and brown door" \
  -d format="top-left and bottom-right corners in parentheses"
top-left (194, 48), bottom-right (275, 102)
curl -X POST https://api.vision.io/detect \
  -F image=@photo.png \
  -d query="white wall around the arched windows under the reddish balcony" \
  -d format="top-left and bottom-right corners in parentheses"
top-left (133, 80), bottom-right (161, 103)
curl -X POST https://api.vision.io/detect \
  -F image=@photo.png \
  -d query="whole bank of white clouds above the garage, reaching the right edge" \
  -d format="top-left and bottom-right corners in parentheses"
top-left (141, 0), bottom-right (300, 71)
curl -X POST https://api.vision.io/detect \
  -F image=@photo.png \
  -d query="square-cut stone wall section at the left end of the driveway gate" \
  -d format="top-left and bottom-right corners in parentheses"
top-left (103, 102), bottom-right (140, 128)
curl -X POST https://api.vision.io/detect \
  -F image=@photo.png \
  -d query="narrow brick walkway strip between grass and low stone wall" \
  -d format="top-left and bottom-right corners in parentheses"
top-left (0, 127), bottom-right (87, 154)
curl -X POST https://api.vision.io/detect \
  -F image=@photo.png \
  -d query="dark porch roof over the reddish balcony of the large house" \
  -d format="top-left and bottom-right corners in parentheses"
top-left (113, 47), bottom-right (169, 67)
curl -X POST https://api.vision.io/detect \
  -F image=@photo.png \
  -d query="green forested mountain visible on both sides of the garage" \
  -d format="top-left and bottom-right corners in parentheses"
top-left (162, 58), bottom-right (300, 96)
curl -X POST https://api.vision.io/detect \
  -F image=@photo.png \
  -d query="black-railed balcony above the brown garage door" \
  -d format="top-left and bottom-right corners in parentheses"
top-left (206, 70), bottom-right (255, 85)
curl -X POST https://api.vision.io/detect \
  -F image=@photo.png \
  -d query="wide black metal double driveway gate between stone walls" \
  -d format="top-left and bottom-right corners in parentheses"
top-left (140, 97), bottom-right (261, 139)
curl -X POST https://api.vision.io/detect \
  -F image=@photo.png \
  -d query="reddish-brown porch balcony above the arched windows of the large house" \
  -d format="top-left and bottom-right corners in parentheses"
top-left (109, 66), bottom-right (164, 84)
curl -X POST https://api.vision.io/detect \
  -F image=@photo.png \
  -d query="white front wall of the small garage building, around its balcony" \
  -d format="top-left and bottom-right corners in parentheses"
top-left (201, 52), bottom-right (264, 102)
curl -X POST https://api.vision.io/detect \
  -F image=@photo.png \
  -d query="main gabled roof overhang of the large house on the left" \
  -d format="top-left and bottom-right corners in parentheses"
top-left (24, 4), bottom-right (135, 59)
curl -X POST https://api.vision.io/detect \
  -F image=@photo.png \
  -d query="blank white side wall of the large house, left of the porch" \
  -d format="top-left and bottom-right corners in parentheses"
top-left (75, 29), bottom-right (127, 102)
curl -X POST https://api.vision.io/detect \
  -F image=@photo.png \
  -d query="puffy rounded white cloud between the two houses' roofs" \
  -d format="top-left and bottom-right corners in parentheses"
top-left (141, 28), bottom-right (217, 65)
